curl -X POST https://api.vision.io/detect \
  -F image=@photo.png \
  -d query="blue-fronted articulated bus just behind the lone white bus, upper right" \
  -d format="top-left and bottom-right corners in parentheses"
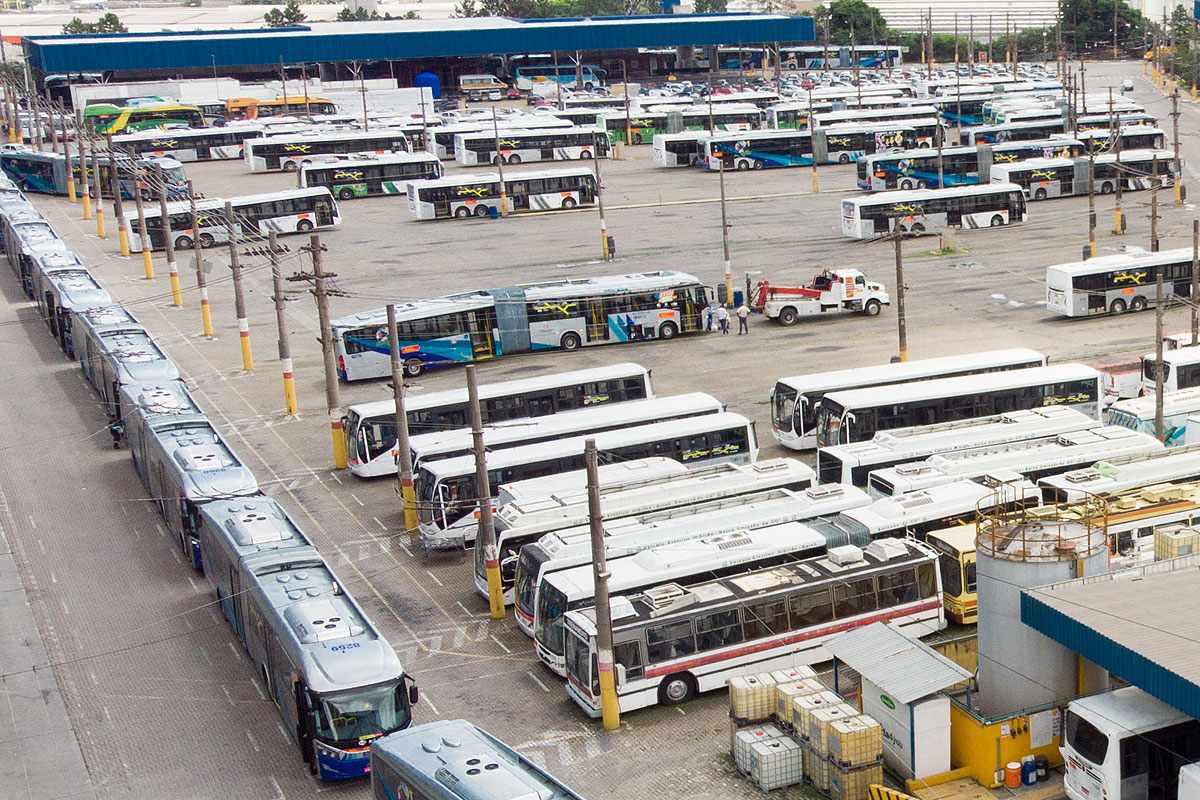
top-left (858, 138), bottom-right (1084, 192)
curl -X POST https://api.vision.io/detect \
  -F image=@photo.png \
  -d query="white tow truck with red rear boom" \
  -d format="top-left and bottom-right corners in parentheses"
top-left (751, 269), bottom-right (892, 325)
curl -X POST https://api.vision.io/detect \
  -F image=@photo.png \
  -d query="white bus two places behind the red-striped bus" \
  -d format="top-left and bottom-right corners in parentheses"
top-left (511, 486), bottom-right (870, 637)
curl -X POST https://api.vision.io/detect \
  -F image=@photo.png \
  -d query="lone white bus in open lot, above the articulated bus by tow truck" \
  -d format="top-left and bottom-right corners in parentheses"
top-left (406, 167), bottom-right (596, 219)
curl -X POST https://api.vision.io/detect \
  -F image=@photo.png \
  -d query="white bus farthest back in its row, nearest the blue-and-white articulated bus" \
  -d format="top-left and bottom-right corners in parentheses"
top-left (342, 363), bottom-right (654, 477)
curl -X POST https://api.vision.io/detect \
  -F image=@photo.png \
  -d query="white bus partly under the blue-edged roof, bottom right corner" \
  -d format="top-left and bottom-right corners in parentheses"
top-left (1062, 686), bottom-right (1200, 800)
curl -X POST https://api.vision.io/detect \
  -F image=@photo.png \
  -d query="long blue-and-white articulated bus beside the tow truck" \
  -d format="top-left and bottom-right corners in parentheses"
top-left (332, 270), bottom-right (712, 381)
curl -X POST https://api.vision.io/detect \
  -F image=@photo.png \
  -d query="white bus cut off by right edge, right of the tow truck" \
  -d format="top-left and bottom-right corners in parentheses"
top-left (1046, 247), bottom-right (1192, 317)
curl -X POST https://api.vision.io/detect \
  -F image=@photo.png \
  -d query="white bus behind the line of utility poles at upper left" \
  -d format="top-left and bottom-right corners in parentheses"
top-left (125, 187), bottom-right (342, 252)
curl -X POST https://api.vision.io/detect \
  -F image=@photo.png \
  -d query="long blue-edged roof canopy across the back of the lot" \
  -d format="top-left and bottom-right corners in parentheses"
top-left (23, 13), bottom-right (815, 73)
